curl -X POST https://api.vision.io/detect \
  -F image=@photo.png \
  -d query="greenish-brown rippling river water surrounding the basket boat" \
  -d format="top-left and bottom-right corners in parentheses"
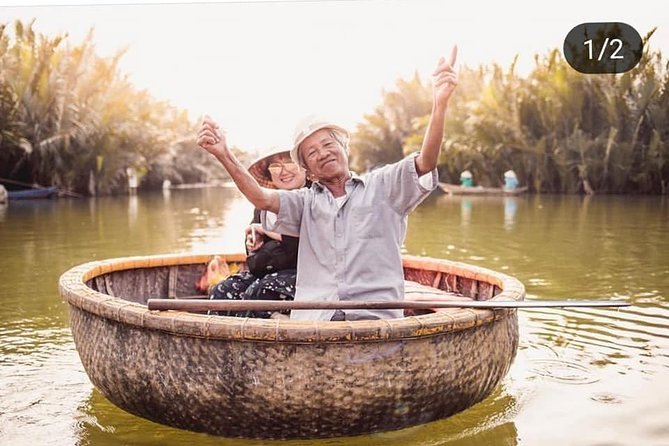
top-left (0, 188), bottom-right (669, 446)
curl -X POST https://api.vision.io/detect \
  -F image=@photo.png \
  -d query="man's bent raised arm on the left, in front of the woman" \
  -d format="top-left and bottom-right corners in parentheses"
top-left (197, 115), bottom-right (279, 214)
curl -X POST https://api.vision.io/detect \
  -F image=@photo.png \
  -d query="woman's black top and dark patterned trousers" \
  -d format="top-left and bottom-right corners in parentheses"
top-left (209, 209), bottom-right (300, 318)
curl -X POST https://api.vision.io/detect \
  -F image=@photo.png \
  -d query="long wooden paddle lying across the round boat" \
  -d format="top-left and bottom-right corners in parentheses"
top-left (147, 299), bottom-right (631, 311)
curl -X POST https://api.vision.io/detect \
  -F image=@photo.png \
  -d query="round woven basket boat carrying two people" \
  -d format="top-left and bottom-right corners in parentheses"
top-left (59, 254), bottom-right (525, 439)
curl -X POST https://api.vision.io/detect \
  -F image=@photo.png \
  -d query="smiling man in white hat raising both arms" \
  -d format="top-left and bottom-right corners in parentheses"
top-left (198, 48), bottom-right (457, 320)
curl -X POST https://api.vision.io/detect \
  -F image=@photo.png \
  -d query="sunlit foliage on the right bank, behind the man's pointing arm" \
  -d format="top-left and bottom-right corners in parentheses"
top-left (352, 32), bottom-right (669, 193)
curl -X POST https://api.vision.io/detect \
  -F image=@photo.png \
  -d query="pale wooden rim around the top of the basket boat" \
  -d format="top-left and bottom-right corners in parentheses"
top-left (58, 254), bottom-right (525, 344)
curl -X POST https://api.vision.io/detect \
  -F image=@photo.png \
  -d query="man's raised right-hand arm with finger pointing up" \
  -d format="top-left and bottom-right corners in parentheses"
top-left (416, 46), bottom-right (458, 176)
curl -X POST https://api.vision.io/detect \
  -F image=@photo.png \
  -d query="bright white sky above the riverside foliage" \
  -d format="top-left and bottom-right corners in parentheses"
top-left (0, 0), bottom-right (669, 152)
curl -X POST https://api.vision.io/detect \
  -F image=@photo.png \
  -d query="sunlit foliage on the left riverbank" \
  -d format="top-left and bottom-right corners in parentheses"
top-left (0, 21), bottom-right (226, 194)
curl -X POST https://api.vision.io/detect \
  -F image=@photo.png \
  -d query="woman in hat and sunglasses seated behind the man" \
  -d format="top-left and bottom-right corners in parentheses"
top-left (209, 151), bottom-right (310, 318)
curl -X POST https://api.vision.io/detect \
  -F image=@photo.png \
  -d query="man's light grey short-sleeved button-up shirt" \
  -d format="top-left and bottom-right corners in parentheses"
top-left (262, 153), bottom-right (438, 320)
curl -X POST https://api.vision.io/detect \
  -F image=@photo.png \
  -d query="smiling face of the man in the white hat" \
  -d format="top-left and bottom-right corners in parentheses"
top-left (299, 129), bottom-right (348, 180)
